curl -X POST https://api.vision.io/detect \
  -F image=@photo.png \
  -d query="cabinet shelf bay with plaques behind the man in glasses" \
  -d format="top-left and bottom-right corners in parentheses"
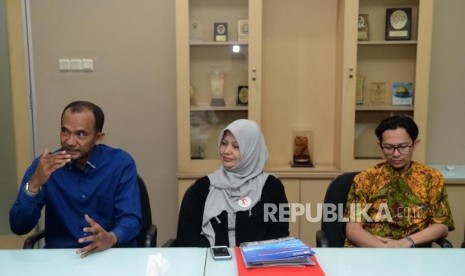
top-left (354, 0), bottom-right (418, 160)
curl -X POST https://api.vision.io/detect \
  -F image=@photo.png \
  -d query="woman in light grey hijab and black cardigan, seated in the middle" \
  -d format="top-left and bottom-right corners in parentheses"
top-left (177, 119), bottom-right (289, 247)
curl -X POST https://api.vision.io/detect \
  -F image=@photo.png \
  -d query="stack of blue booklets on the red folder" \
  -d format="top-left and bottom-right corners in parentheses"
top-left (239, 237), bottom-right (315, 268)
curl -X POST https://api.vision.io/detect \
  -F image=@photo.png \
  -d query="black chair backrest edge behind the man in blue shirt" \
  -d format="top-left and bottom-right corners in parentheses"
top-left (137, 175), bottom-right (156, 247)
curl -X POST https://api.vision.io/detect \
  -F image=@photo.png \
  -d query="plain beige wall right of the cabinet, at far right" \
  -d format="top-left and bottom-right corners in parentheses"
top-left (426, 0), bottom-right (465, 164)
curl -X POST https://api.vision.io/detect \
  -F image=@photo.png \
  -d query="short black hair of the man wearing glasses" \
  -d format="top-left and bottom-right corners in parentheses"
top-left (375, 115), bottom-right (418, 143)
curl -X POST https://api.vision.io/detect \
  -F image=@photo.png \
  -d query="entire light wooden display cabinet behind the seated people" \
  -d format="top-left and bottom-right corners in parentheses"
top-left (176, 0), bottom-right (434, 244)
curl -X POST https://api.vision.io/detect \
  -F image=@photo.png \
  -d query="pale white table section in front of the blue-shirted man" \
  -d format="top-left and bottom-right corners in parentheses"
top-left (0, 248), bottom-right (207, 276)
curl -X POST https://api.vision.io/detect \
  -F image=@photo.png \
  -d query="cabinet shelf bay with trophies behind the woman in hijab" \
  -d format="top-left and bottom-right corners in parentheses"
top-left (189, 0), bottom-right (249, 159)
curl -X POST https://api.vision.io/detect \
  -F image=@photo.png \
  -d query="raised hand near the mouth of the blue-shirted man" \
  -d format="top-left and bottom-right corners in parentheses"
top-left (29, 148), bottom-right (71, 193)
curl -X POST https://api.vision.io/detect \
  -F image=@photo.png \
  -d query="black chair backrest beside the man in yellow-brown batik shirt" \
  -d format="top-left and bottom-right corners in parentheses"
top-left (321, 172), bottom-right (359, 247)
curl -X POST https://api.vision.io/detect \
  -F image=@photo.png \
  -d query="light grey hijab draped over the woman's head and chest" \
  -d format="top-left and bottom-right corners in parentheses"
top-left (202, 119), bottom-right (268, 246)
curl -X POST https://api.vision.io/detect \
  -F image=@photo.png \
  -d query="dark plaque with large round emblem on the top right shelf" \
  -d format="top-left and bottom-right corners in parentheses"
top-left (386, 8), bottom-right (412, 40)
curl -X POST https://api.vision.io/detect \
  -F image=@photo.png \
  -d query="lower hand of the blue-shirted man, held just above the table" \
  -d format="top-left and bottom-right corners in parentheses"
top-left (76, 214), bottom-right (118, 258)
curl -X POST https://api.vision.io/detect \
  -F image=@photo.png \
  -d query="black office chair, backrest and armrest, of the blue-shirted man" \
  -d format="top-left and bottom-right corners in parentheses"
top-left (23, 175), bottom-right (157, 249)
